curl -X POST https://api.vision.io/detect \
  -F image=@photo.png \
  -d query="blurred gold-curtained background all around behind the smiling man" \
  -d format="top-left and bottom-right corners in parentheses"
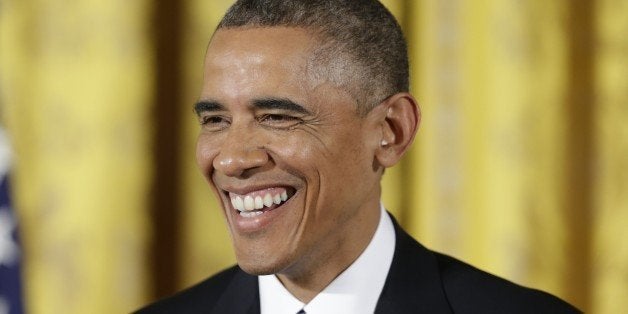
top-left (0, 0), bottom-right (628, 314)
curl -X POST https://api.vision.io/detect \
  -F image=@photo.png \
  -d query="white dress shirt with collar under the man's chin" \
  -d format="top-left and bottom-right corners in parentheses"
top-left (258, 206), bottom-right (395, 314)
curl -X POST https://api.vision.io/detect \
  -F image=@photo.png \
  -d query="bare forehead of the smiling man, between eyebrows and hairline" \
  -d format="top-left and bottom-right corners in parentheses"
top-left (201, 27), bottom-right (316, 104)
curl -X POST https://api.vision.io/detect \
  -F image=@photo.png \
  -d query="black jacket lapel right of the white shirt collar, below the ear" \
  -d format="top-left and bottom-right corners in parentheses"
top-left (375, 216), bottom-right (453, 314)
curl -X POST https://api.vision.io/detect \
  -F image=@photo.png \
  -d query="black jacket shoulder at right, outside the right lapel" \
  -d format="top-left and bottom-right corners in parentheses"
top-left (433, 252), bottom-right (580, 313)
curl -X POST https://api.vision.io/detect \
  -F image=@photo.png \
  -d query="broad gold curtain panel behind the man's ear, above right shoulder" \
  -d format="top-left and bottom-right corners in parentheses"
top-left (403, 1), bottom-right (580, 302)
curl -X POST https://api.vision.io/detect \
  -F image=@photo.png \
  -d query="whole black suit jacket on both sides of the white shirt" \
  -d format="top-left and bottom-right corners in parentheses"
top-left (137, 219), bottom-right (580, 314)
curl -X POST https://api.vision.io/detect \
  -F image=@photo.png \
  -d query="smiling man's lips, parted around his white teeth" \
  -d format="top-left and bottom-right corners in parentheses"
top-left (222, 184), bottom-right (298, 234)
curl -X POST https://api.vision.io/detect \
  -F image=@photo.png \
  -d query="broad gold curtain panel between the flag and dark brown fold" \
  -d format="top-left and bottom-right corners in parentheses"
top-left (0, 0), bottom-right (153, 313)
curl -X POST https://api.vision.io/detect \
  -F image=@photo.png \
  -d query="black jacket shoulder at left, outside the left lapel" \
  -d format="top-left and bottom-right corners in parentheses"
top-left (135, 266), bottom-right (247, 314)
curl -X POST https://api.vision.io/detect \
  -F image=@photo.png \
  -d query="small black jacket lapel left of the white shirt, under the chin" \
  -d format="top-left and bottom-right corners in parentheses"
top-left (212, 269), bottom-right (260, 314)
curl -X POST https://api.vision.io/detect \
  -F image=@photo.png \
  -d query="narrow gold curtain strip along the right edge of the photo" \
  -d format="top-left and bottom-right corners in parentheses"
top-left (587, 0), bottom-right (628, 313)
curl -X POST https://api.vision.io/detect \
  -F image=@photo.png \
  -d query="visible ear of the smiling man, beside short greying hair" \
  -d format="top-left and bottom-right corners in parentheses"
top-left (375, 93), bottom-right (421, 168)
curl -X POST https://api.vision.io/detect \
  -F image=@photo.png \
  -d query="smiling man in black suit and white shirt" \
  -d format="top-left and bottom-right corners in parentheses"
top-left (140, 0), bottom-right (577, 314)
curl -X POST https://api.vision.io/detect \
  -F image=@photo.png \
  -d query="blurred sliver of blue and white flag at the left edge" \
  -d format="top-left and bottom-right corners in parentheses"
top-left (0, 128), bottom-right (24, 314)
